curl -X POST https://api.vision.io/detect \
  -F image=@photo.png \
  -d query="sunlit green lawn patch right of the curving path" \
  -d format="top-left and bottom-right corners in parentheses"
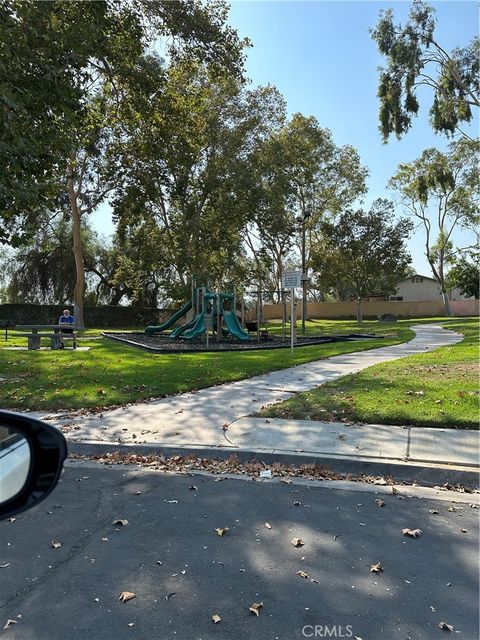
top-left (262, 318), bottom-right (479, 429)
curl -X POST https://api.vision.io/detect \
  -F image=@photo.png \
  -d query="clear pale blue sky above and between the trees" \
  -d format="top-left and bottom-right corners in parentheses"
top-left (92, 0), bottom-right (479, 275)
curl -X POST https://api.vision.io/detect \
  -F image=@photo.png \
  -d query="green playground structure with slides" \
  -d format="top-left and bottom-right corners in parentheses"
top-left (145, 282), bottom-right (250, 345)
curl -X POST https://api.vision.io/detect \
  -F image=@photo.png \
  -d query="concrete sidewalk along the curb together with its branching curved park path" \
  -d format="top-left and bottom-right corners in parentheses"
top-left (37, 325), bottom-right (479, 484)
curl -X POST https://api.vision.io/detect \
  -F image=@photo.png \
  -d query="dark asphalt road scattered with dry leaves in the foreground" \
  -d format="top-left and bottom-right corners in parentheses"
top-left (0, 464), bottom-right (479, 640)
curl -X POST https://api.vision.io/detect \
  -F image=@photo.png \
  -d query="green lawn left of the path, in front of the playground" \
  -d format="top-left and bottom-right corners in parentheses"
top-left (0, 320), bottom-right (417, 411)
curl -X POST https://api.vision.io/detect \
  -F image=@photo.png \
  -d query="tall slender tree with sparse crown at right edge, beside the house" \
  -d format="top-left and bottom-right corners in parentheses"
top-left (389, 139), bottom-right (480, 315)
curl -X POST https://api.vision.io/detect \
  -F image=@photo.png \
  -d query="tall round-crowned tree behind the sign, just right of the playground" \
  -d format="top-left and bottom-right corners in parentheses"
top-left (248, 113), bottom-right (367, 300)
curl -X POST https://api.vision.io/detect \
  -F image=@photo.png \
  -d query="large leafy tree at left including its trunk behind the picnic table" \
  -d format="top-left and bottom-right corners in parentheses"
top-left (0, 0), bottom-right (245, 327)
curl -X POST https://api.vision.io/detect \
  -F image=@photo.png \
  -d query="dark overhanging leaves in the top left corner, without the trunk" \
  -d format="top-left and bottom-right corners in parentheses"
top-left (0, 0), bottom-right (245, 244)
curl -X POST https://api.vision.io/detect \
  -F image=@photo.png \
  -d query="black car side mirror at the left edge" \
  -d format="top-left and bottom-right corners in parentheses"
top-left (0, 411), bottom-right (67, 520)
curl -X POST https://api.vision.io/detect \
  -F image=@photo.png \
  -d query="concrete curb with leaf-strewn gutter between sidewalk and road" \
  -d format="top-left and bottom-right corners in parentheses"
top-left (67, 440), bottom-right (480, 489)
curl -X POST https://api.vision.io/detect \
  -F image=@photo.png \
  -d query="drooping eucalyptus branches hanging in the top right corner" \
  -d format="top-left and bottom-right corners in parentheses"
top-left (370, 0), bottom-right (480, 142)
